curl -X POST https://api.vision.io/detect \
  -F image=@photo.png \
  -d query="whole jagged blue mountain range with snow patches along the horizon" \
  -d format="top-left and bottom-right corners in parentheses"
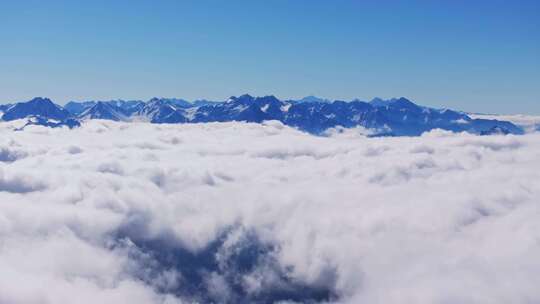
top-left (0, 94), bottom-right (523, 136)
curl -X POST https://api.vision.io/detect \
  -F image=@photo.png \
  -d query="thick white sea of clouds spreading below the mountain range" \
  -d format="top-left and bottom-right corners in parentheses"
top-left (0, 121), bottom-right (540, 304)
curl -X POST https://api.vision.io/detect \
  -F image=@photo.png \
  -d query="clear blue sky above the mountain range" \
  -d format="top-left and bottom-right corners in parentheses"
top-left (0, 0), bottom-right (540, 114)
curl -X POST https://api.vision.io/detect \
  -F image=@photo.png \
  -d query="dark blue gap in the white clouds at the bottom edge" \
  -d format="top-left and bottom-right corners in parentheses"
top-left (112, 225), bottom-right (337, 303)
